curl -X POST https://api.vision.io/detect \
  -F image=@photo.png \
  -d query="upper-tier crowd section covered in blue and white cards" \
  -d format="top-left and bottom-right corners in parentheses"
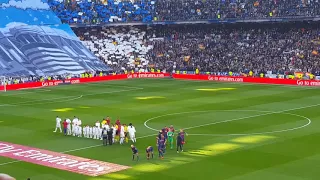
top-left (49, 0), bottom-right (155, 24)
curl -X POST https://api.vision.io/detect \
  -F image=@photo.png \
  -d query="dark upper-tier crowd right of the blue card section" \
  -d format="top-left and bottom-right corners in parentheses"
top-left (156, 0), bottom-right (320, 21)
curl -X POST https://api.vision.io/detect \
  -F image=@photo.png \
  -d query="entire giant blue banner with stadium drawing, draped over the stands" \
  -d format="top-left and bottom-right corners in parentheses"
top-left (0, 0), bottom-right (110, 76)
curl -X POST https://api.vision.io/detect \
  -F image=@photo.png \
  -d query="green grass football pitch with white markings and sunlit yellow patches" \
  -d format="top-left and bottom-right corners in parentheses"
top-left (0, 79), bottom-right (320, 180)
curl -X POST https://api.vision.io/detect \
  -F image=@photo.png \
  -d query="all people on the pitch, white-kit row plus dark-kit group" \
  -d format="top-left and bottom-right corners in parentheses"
top-left (53, 116), bottom-right (187, 160)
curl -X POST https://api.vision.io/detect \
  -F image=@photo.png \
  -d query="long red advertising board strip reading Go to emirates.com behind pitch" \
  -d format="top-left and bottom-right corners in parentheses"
top-left (0, 73), bottom-right (320, 91)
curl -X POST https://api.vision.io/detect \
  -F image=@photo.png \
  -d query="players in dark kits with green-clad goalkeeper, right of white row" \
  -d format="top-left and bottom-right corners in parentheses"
top-left (131, 125), bottom-right (187, 161)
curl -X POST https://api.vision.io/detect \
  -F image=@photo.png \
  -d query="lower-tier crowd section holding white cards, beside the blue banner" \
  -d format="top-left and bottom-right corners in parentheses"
top-left (76, 27), bottom-right (153, 71)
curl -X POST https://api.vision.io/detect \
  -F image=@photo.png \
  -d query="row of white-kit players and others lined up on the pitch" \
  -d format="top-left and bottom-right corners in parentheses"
top-left (53, 116), bottom-right (137, 145)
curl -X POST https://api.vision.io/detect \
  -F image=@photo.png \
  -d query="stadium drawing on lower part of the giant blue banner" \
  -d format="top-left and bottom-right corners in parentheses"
top-left (0, 24), bottom-right (110, 76)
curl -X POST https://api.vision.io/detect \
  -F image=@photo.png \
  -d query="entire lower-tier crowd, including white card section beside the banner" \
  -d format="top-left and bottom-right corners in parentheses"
top-left (75, 24), bottom-right (320, 75)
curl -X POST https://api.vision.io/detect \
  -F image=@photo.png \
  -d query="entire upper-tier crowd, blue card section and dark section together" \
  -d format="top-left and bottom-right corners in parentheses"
top-left (49, 0), bottom-right (320, 24)
